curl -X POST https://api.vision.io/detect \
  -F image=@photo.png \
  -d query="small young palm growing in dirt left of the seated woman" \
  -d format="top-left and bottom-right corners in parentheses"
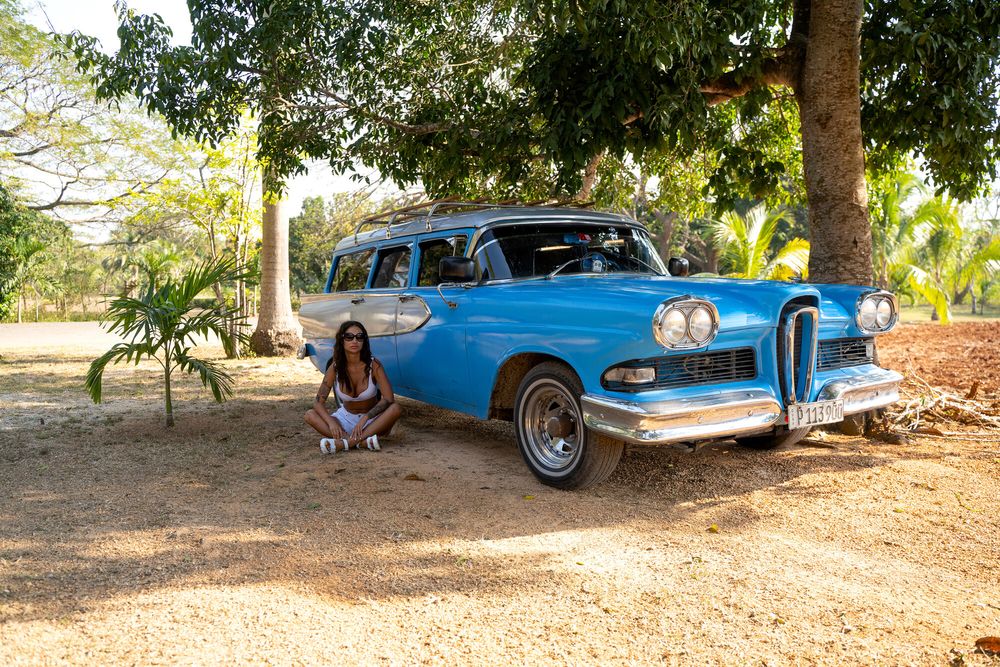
top-left (85, 259), bottom-right (248, 426)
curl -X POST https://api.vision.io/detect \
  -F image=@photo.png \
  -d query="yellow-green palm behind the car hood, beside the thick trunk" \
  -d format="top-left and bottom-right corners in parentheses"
top-left (712, 204), bottom-right (809, 280)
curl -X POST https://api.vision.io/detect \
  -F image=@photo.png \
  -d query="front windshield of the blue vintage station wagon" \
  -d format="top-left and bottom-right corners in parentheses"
top-left (473, 222), bottom-right (667, 280)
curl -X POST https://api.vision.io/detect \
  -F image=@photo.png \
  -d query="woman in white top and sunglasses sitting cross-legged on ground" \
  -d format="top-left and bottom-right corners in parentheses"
top-left (306, 320), bottom-right (402, 454)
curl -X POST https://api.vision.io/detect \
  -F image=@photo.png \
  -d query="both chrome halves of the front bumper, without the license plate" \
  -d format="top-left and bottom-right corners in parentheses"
top-left (580, 368), bottom-right (903, 445)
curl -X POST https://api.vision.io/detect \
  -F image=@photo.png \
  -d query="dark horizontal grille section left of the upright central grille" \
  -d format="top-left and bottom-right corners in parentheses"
top-left (602, 347), bottom-right (757, 391)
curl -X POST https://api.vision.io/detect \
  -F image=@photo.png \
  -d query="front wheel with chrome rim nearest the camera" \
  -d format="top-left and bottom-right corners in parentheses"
top-left (514, 362), bottom-right (625, 489)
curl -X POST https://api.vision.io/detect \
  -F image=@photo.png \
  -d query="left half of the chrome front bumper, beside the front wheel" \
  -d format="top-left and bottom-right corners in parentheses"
top-left (580, 389), bottom-right (782, 445)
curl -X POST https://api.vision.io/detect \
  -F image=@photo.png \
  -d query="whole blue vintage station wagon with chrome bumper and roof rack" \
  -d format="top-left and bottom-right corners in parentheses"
top-left (299, 202), bottom-right (902, 489)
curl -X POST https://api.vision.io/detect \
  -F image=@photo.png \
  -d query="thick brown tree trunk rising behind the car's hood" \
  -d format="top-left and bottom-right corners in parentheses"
top-left (796, 0), bottom-right (872, 285)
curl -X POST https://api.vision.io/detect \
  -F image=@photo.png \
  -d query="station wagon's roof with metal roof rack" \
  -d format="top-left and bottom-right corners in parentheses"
top-left (336, 203), bottom-right (642, 250)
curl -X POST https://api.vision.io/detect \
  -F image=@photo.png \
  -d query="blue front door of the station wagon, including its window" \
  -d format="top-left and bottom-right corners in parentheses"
top-left (396, 231), bottom-right (471, 410)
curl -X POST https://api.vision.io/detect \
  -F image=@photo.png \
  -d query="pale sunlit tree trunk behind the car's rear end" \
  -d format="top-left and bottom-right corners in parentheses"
top-left (250, 170), bottom-right (302, 357)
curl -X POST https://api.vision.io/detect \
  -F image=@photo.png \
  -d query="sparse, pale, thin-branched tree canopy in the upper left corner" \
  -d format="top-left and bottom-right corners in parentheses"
top-left (0, 0), bottom-right (179, 222)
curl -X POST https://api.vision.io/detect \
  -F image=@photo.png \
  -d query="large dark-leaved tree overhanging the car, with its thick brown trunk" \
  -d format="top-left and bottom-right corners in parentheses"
top-left (71, 0), bottom-right (1000, 280)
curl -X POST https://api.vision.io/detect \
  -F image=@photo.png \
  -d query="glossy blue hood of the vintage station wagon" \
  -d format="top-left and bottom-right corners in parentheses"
top-left (476, 274), bottom-right (849, 330)
